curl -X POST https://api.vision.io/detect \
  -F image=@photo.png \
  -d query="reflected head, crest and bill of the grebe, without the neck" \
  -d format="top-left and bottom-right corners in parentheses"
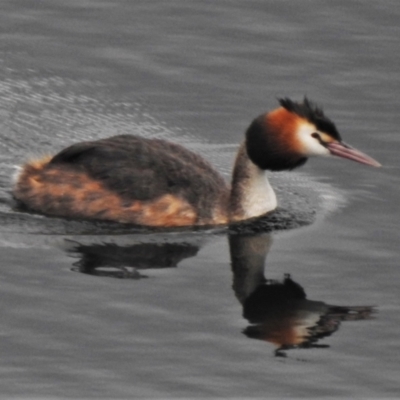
top-left (243, 275), bottom-right (375, 356)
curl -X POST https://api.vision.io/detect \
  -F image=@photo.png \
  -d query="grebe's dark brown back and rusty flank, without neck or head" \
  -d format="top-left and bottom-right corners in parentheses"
top-left (13, 136), bottom-right (228, 226)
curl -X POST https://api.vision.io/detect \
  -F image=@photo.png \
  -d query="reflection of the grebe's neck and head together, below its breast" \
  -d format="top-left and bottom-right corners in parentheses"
top-left (229, 234), bottom-right (374, 356)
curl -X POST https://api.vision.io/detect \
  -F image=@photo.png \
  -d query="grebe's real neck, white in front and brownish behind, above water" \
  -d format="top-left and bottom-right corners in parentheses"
top-left (229, 143), bottom-right (277, 222)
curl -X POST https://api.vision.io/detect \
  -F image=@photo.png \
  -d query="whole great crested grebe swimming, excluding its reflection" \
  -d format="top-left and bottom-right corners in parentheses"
top-left (13, 98), bottom-right (380, 227)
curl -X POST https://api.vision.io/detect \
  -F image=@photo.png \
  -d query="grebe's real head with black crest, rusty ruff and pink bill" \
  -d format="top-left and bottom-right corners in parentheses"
top-left (246, 98), bottom-right (380, 171)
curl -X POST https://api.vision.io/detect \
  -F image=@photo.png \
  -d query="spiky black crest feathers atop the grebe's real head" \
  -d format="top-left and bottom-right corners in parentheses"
top-left (279, 97), bottom-right (341, 141)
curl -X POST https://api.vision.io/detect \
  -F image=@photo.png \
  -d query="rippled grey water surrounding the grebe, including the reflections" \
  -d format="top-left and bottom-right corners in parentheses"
top-left (0, 0), bottom-right (400, 398)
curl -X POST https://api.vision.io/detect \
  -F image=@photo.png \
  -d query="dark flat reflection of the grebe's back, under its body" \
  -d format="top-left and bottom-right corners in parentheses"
top-left (69, 241), bottom-right (200, 279)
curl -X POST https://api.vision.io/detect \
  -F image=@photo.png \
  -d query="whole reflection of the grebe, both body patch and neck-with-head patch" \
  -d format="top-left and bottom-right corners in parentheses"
top-left (66, 232), bottom-right (375, 357)
